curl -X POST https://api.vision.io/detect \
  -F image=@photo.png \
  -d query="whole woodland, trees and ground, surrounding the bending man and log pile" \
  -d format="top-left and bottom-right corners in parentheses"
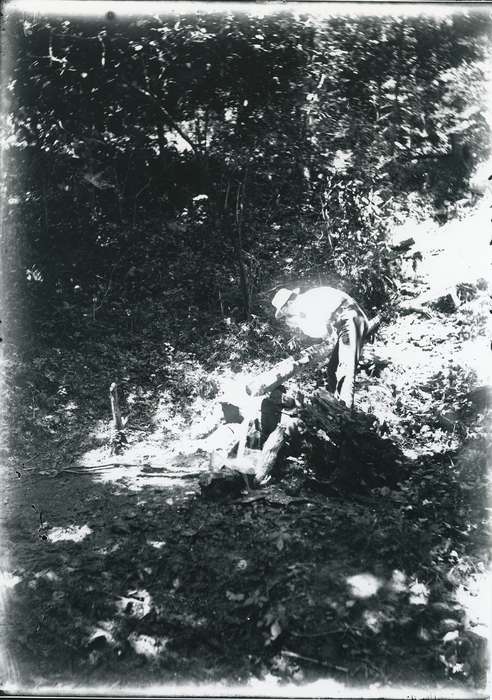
top-left (0, 5), bottom-right (492, 692)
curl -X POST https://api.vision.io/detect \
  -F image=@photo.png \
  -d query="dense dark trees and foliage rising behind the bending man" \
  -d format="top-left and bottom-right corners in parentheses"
top-left (2, 10), bottom-right (489, 350)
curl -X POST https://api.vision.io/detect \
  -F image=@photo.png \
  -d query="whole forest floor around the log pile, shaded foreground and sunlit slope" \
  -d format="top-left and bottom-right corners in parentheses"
top-left (0, 206), bottom-right (490, 696)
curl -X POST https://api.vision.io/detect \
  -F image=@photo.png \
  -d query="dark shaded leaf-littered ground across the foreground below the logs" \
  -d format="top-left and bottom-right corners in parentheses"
top-left (6, 410), bottom-right (487, 686)
